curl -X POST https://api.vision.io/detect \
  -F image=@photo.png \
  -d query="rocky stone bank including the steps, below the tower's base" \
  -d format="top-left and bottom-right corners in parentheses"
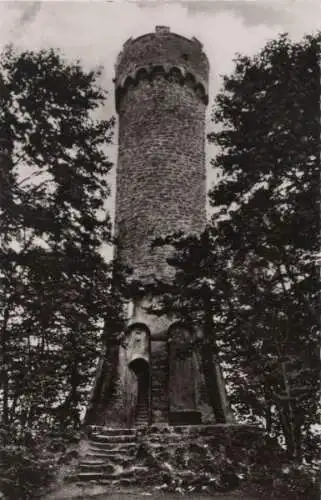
top-left (43, 425), bottom-right (284, 499)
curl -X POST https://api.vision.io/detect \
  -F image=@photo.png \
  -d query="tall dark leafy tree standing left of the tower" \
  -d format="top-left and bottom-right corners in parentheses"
top-left (0, 47), bottom-right (118, 429)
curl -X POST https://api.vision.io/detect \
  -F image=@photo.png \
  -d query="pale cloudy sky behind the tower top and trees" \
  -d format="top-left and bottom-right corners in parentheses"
top-left (0, 0), bottom-right (321, 256)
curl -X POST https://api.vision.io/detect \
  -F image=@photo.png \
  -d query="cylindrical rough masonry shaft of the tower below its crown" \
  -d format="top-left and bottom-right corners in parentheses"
top-left (116, 72), bottom-right (206, 286)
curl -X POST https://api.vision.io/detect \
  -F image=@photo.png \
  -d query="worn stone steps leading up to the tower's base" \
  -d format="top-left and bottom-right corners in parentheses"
top-left (70, 427), bottom-right (147, 486)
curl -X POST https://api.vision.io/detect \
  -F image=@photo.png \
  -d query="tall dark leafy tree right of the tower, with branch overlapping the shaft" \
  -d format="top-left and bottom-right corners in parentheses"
top-left (149, 30), bottom-right (320, 460)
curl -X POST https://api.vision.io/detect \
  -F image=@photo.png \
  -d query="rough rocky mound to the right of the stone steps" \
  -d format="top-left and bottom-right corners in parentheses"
top-left (137, 424), bottom-right (272, 492)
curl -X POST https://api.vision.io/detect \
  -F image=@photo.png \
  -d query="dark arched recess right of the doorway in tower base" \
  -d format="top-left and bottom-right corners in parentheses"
top-left (168, 323), bottom-right (196, 412)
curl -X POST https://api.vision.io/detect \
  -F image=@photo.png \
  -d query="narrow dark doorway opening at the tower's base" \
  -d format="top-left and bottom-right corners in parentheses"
top-left (129, 358), bottom-right (150, 426)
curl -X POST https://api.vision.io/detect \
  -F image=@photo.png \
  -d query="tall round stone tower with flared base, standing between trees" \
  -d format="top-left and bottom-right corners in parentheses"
top-left (87, 26), bottom-right (228, 427)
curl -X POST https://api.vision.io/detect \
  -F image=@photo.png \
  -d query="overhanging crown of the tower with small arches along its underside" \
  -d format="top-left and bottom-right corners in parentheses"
top-left (114, 26), bottom-right (209, 109)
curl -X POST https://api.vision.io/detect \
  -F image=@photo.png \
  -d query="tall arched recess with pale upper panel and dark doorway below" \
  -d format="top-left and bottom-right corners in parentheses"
top-left (126, 323), bottom-right (151, 424)
